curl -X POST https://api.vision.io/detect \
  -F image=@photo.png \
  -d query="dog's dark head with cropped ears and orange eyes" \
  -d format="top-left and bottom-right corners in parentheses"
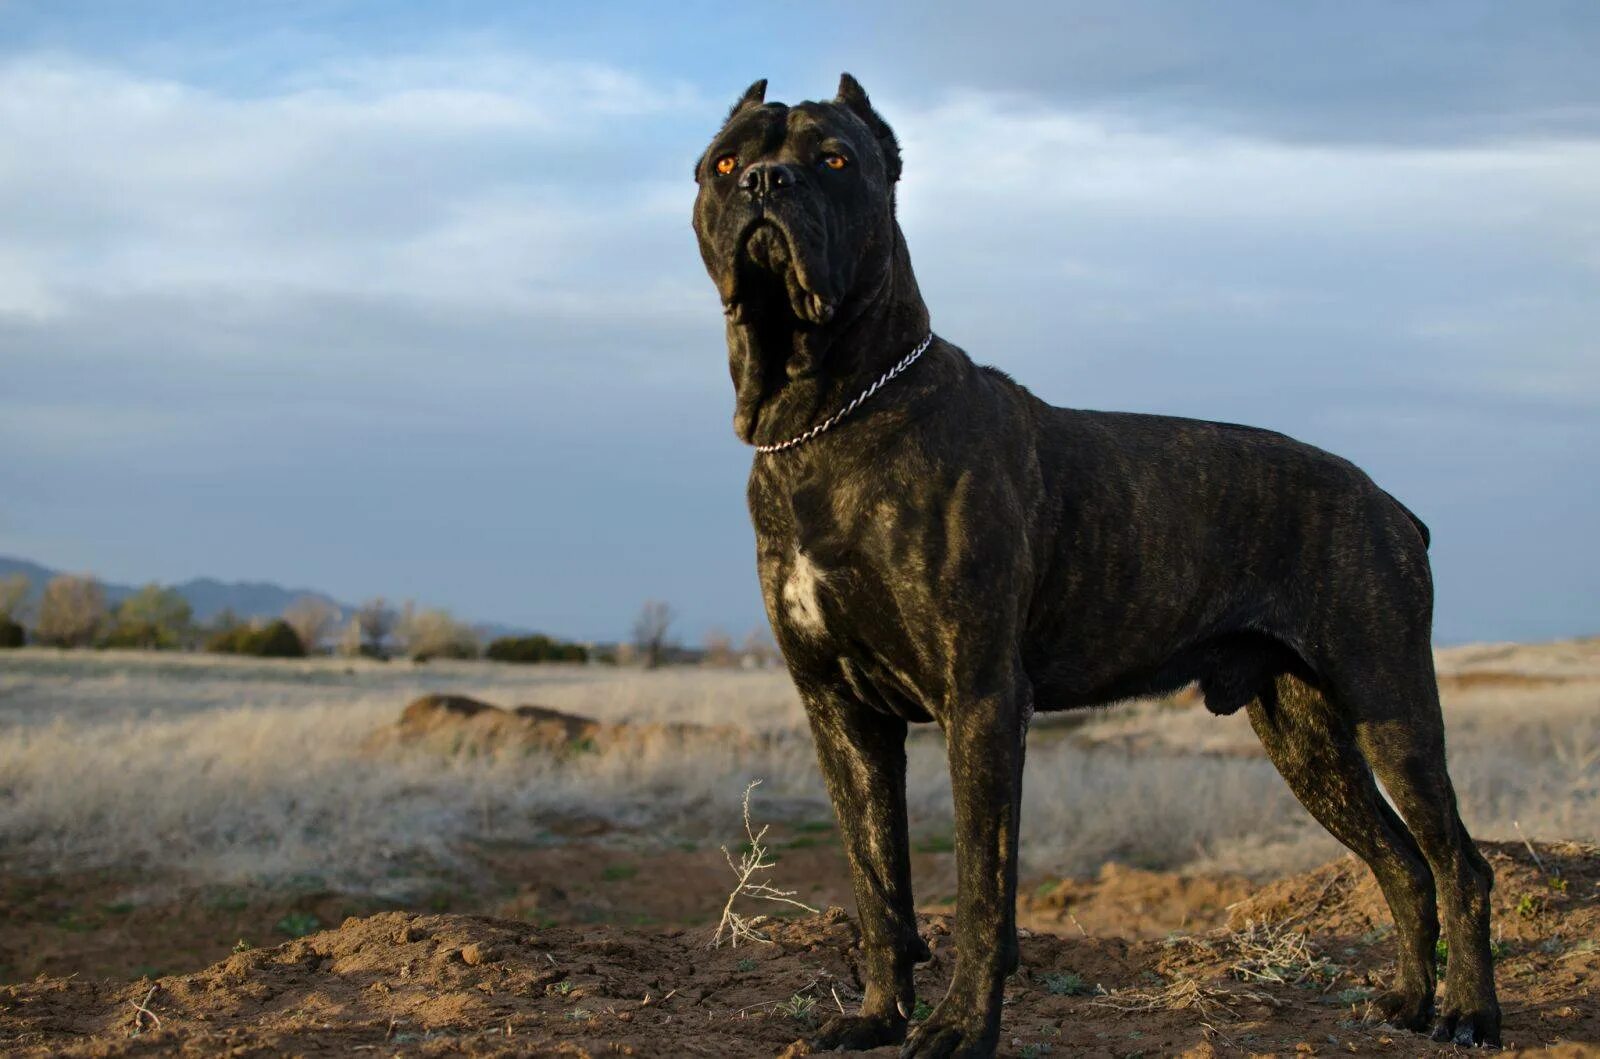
top-left (694, 74), bottom-right (901, 328)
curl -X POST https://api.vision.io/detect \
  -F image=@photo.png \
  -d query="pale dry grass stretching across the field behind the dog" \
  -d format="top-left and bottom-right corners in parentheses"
top-left (0, 649), bottom-right (1600, 893)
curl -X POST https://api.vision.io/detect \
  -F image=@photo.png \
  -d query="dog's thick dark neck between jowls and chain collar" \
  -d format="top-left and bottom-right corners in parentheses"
top-left (728, 224), bottom-right (928, 445)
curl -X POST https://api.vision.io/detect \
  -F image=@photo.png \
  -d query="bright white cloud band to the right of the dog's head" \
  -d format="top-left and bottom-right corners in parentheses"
top-left (883, 93), bottom-right (1600, 402)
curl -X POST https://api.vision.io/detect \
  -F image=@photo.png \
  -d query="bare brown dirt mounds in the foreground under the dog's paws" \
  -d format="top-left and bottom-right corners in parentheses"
top-left (0, 843), bottom-right (1600, 1056)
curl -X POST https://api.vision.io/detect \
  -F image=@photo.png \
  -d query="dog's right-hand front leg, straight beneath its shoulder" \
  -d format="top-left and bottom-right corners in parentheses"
top-left (901, 675), bottom-right (1032, 1059)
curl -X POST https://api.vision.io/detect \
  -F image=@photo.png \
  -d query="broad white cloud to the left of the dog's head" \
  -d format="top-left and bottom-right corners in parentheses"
top-left (0, 58), bottom-right (707, 332)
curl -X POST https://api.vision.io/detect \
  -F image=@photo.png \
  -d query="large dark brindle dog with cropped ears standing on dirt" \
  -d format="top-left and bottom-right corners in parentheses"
top-left (694, 74), bottom-right (1499, 1056)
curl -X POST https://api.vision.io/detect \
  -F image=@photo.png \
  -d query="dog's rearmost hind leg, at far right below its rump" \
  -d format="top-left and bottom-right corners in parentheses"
top-left (1355, 665), bottom-right (1501, 1045)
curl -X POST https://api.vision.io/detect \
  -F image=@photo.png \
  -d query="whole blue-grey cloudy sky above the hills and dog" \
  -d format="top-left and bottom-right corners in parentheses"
top-left (0, 0), bottom-right (1600, 641)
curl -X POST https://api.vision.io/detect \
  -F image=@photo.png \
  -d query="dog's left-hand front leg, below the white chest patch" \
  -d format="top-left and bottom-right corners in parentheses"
top-left (803, 688), bottom-right (928, 1051)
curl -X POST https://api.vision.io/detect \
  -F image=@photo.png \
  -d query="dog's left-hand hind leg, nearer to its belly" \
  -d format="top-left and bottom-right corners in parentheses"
top-left (1248, 673), bottom-right (1438, 1030)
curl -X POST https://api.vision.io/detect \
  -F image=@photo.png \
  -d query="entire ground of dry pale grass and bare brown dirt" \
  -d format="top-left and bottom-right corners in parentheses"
top-left (0, 640), bottom-right (1600, 1056)
